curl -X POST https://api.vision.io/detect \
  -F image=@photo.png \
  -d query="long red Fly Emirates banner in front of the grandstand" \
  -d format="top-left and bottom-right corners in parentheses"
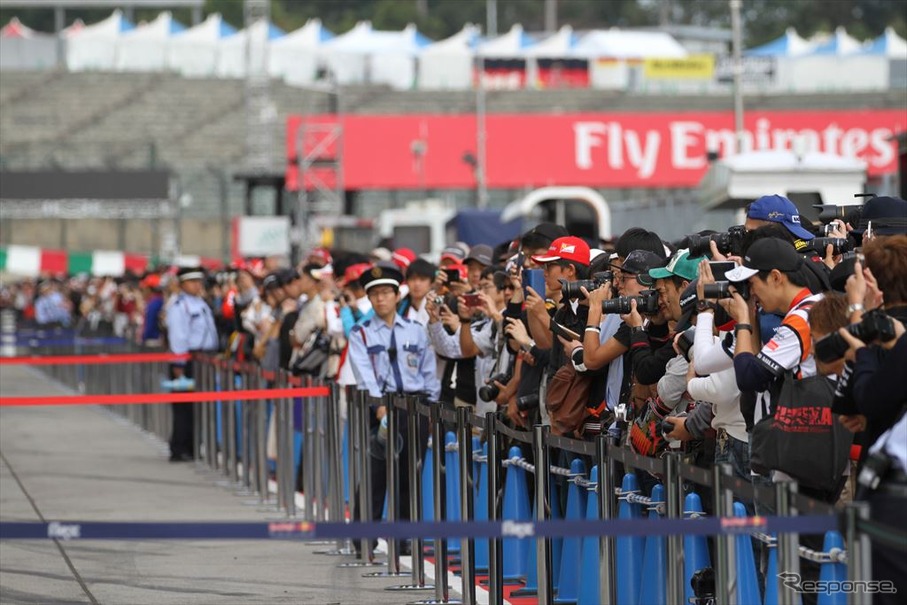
top-left (287, 110), bottom-right (907, 190)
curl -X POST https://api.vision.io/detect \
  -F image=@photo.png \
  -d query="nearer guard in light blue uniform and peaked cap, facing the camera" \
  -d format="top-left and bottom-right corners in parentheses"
top-left (348, 265), bottom-right (441, 554)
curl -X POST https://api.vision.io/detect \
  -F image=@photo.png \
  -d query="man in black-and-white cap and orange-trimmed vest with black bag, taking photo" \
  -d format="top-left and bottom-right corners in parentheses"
top-left (719, 237), bottom-right (850, 596)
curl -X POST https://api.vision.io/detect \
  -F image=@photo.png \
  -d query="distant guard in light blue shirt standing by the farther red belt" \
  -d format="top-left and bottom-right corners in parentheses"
top-left (167, 267), bottom-right (217, 462)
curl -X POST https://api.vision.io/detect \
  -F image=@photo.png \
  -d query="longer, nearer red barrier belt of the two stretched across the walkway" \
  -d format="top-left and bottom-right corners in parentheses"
top-left (0, 387), bottom-right (331, 407)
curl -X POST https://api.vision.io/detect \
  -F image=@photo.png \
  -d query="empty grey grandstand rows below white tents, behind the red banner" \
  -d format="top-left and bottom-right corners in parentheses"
top-left (0, 72), bottom-right (903, 175)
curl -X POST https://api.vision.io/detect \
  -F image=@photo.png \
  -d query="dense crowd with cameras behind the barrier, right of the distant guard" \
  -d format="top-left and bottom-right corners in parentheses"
top-left (3, 195), bottom-right (907, 602)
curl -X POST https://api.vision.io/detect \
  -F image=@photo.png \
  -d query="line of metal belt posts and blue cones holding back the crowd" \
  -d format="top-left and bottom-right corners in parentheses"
top-left (6, 316), bottom-right (904, 605)
